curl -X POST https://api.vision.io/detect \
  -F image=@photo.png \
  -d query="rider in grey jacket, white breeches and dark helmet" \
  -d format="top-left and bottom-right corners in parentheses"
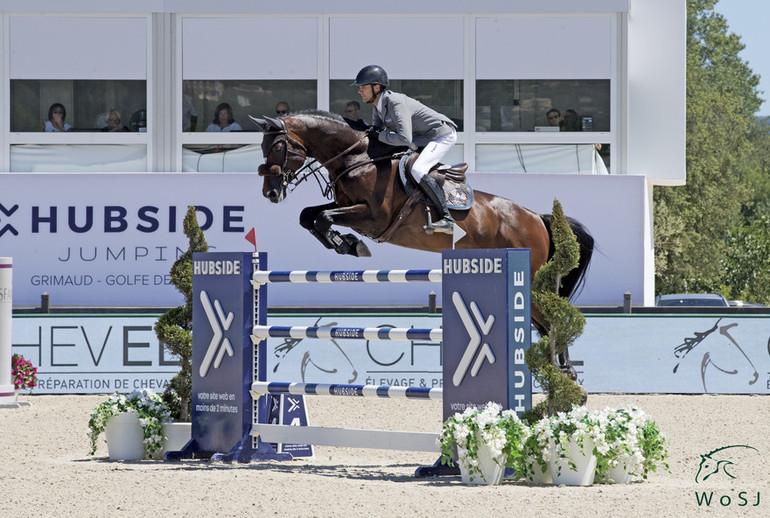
top-left (350, 65), bottom-right (457, 234)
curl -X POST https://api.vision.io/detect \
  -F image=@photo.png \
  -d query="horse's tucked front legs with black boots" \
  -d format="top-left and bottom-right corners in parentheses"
top-left (299, 202), bottom-right (372, 257)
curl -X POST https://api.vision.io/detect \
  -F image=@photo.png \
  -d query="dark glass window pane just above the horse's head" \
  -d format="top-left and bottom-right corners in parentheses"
top-left (182, 79), bottom-right (318, 131)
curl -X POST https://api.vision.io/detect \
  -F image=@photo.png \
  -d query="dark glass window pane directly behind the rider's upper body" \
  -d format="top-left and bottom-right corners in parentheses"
top-left (329, 79), bottom-right (463, 131)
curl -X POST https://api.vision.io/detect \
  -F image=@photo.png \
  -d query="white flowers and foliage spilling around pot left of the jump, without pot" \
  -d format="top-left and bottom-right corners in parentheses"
top-left (88, 389), bottom-right (170, 457)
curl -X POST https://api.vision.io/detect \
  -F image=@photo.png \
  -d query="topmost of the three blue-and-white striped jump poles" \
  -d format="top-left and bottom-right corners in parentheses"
top-left (251, 270), bottom-right (441, 285)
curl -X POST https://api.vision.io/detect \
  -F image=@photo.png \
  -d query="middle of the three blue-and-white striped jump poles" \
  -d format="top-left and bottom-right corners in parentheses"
top-left (252, 325), bottom-right (444, 343)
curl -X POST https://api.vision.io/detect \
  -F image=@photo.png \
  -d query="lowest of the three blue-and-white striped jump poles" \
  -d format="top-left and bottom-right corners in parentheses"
top-left (251, 381), bottom-right (443, 399)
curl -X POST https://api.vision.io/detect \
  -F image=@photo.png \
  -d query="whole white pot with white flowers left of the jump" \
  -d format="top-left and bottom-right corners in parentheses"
top-left (88, 389), bottom-right (170, 460)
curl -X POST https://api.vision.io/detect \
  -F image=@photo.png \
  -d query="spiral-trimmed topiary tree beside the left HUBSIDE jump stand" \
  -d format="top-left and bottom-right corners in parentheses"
top-left (155, 206), bottom-right (209, 421)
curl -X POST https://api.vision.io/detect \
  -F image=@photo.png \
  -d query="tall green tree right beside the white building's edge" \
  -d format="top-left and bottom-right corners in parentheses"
top-left (653, 0), bottom-right (761, 293)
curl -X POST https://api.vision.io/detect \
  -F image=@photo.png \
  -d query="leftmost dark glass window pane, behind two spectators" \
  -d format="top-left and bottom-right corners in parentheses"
top-left (11, 79), bottom-right (147, 132)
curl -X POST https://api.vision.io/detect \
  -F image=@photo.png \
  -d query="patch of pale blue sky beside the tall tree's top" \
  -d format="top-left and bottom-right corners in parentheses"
top-left (714, 0), bottom-right (770, 116)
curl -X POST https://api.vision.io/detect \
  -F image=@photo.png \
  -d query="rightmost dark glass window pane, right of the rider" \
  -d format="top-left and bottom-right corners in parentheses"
top-left (476, 79), bottom-right (610, 132)
